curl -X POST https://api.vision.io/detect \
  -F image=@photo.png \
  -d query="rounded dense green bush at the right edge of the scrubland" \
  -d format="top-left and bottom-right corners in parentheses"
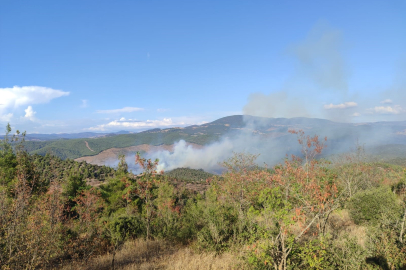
top-left (348, 186), bottom-right (401, 224)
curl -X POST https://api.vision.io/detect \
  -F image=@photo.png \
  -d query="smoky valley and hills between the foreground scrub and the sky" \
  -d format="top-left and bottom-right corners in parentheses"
top-left (16, 115), bottom-right (406, 172)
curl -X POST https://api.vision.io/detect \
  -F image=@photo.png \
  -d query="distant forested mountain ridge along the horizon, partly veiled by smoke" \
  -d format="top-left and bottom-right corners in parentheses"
top-left (17, 115), bottom-right (406, 159)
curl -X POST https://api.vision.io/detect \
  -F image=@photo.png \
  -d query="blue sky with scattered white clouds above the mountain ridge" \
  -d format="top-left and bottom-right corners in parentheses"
top-left (0, 0), bottom-right (406, 133)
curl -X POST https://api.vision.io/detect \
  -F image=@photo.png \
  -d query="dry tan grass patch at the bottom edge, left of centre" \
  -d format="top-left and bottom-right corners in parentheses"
top-left (62, 240), bottom-right (243, 270)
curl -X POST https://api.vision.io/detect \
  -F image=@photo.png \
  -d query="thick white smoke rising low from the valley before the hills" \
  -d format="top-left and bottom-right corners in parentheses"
top-left (147, 118), bottom-right (297, 173)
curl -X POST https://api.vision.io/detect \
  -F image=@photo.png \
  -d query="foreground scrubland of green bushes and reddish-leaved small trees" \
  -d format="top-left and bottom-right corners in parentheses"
top-left (0, 123), bottom-right (406, 270)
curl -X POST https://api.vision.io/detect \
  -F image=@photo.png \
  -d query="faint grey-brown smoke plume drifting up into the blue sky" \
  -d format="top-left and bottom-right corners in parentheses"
top-left (243, 23), bottom-right (353, 121)
